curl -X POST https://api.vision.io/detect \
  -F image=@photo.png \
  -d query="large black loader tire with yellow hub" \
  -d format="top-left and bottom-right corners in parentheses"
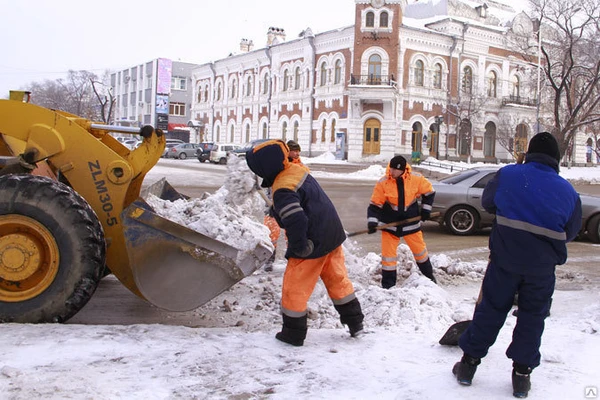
top-left (0, 175), bottom-right (106, 323)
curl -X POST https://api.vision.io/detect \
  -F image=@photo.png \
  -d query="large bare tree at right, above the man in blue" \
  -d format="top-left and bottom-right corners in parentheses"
top-left (525, 0), bottom-right (600, 159)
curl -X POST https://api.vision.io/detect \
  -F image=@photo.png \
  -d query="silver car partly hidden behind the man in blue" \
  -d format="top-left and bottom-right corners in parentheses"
top-left (432, 166), bottom-right (600, 243)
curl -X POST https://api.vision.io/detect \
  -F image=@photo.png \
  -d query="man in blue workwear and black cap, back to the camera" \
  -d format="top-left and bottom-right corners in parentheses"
top-left (452, 132), bottom-right (582, 398)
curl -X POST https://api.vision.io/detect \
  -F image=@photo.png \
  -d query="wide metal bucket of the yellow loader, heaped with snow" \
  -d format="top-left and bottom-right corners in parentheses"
top-left (122, 181), bottom-right (272, 311)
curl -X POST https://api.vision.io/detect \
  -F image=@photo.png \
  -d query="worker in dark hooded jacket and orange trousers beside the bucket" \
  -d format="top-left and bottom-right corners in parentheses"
top-left (246, 140), bottom-right (364, 346)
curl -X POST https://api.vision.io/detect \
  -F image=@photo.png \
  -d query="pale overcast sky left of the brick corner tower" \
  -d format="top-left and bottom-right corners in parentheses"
top-left (0, 0), bottom-right (355, 98)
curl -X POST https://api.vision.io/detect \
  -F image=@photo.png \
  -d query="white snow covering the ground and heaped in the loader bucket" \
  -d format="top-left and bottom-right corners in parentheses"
top-left (0, 155), bottom-right (600, 400)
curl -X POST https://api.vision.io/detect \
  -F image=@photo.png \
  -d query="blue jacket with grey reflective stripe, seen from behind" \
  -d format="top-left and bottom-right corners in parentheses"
top-left (481, 153), bottom-right (582, 275)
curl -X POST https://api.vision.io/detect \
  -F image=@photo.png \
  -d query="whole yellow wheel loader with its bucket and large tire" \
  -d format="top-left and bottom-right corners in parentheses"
top-left (0, 91), bottom-right (271, 323)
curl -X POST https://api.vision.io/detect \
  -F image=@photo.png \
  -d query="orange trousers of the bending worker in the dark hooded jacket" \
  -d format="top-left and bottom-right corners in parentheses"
top-left (281, 246), bottom-right (356, 318)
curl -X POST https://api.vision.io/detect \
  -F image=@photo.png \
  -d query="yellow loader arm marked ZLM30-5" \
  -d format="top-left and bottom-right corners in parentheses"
top-left (0, 100), bottom-right (165, 298)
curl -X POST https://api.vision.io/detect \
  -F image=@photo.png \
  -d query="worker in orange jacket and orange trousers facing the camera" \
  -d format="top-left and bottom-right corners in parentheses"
top-left (367, 156), bottom-right (436, 289)
